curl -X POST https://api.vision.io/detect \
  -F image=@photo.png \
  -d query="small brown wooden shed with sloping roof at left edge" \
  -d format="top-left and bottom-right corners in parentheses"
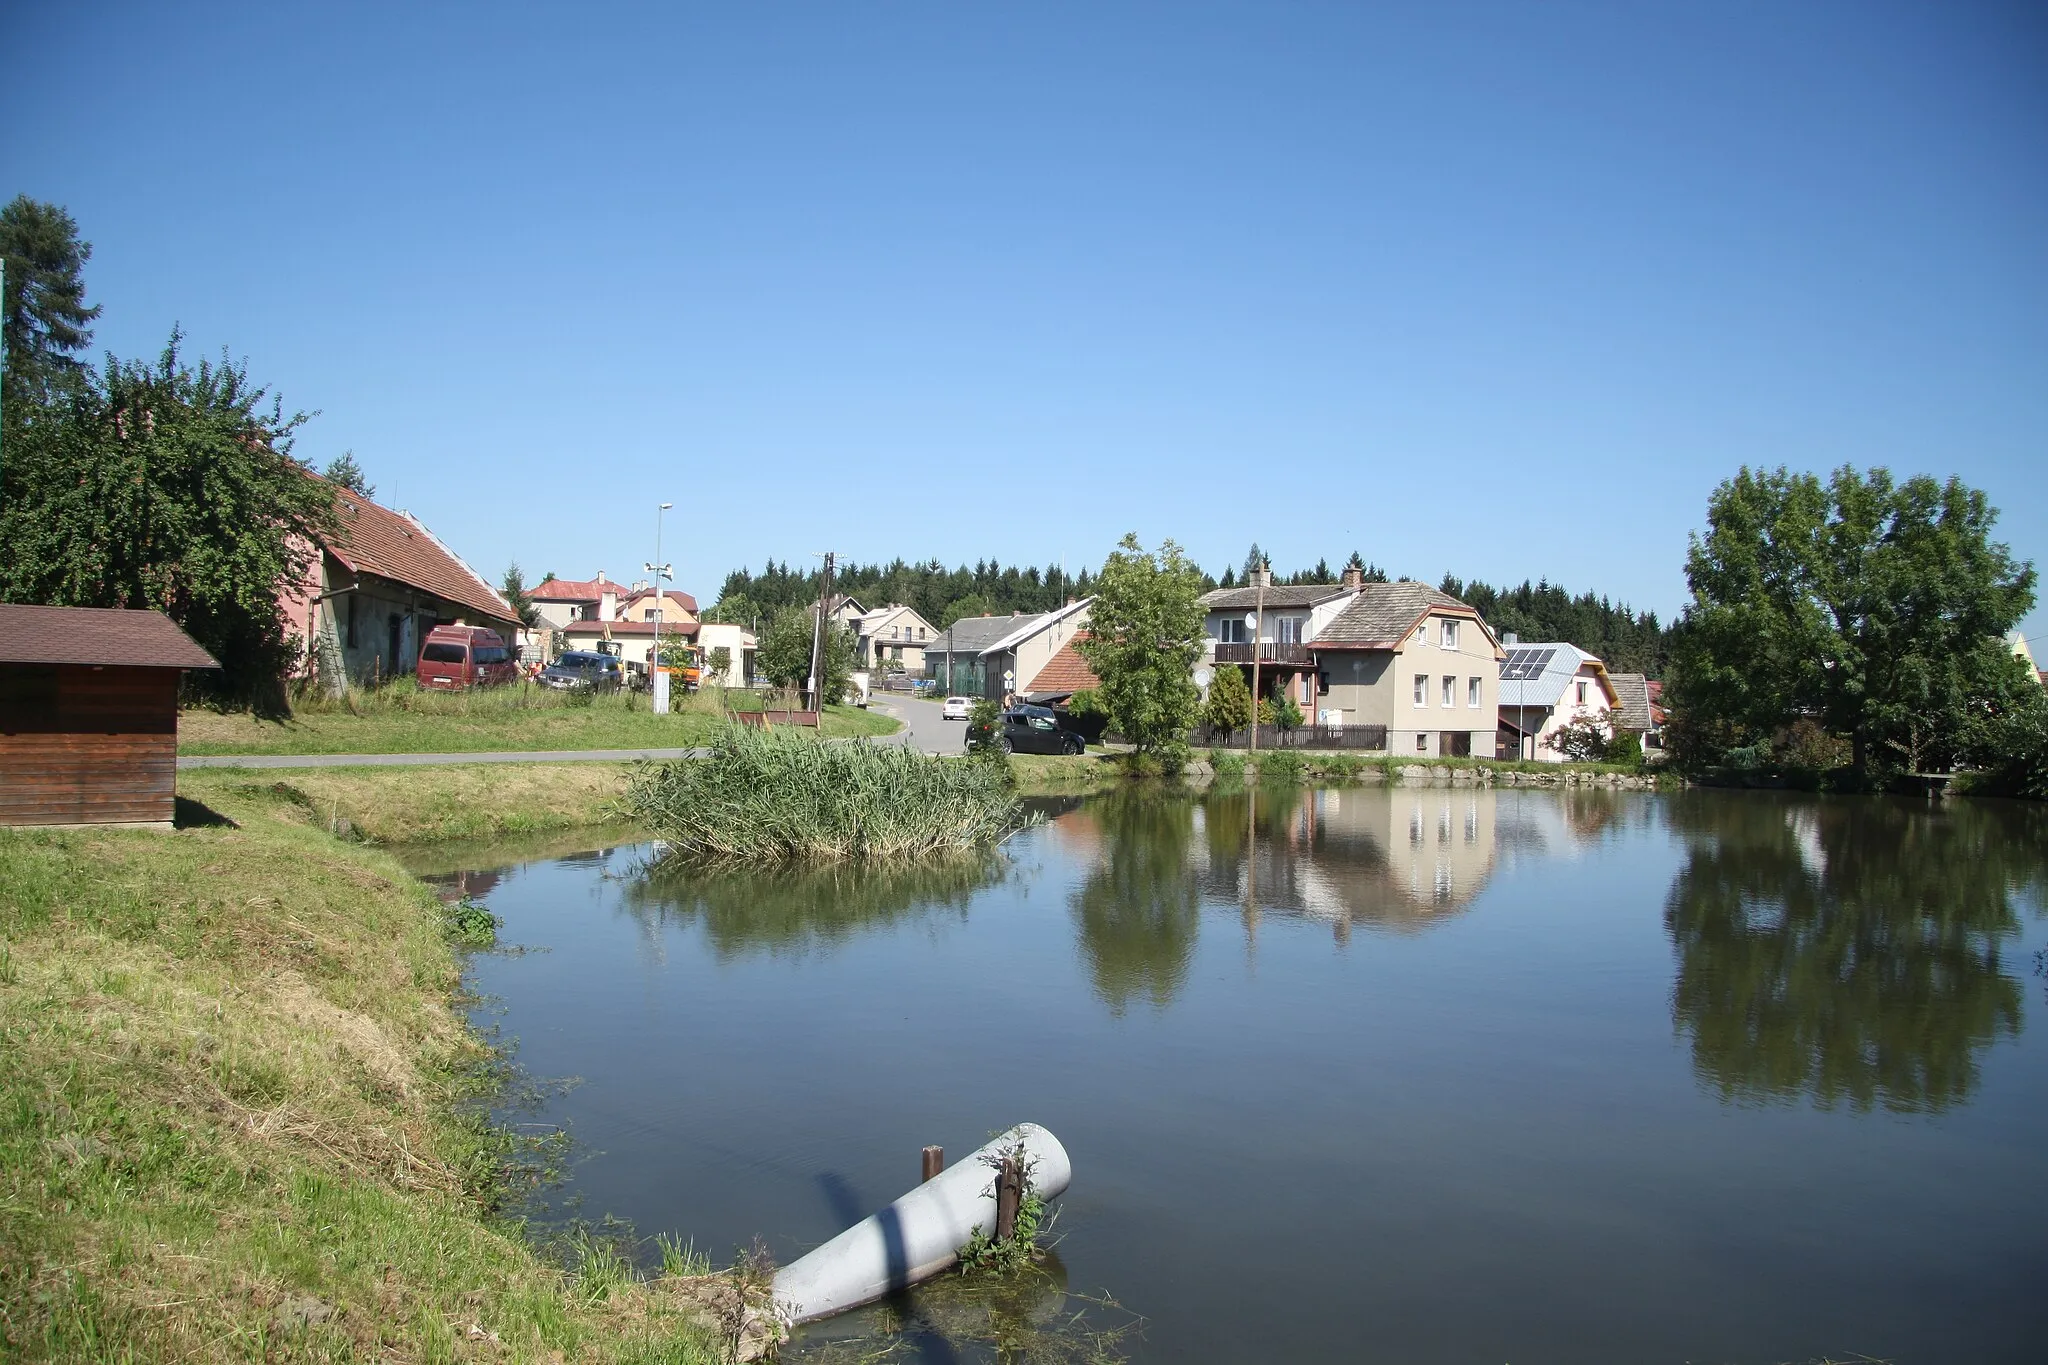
top-left (0, 604), bottom-right (219, 829)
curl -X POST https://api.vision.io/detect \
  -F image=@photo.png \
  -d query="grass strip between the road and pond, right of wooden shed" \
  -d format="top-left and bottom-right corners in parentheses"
top-left (178, 763), bottom-right (647, 843)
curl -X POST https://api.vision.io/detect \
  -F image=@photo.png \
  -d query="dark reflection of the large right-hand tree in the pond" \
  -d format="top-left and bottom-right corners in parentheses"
top-left (1665, 794), bottom-right (2042, 1111)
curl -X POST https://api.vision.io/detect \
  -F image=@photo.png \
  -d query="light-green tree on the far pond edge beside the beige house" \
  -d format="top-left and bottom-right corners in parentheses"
top-left (1079, 534), bottom-right (1202, 767)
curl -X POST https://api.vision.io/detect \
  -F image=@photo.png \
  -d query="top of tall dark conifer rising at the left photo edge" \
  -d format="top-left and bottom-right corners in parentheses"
top-left (0, 194), bottom-right (100, 405)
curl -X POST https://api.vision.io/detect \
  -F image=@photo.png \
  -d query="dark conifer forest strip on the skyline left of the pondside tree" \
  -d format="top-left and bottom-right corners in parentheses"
top-left (711, 559), bottom-right (1096, 630)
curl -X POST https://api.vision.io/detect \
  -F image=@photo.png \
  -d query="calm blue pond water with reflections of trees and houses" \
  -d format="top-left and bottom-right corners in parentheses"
top-left (411, 788), bottom-right (2048, 1365)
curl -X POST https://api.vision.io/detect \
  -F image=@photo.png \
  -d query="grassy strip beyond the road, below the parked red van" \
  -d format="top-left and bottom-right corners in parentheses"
top-left (178, 681), bottom-right (897, 753)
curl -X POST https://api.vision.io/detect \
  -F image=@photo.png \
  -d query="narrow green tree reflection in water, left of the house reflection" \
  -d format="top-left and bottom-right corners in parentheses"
top-left (1063, 792), bottom-right (1202, 1015)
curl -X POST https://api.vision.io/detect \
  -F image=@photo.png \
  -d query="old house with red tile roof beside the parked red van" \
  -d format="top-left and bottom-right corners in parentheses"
top-left (279, 475), bottom-right (520, 690)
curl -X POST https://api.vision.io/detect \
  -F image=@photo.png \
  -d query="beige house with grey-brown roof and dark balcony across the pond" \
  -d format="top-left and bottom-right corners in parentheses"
top-left (1202, 569), bottom-right (1501, 757)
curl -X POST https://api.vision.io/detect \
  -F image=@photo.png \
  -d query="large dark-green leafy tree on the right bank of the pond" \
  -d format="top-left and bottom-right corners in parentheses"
top-left (1667, 467), bottom-right (2042, 774)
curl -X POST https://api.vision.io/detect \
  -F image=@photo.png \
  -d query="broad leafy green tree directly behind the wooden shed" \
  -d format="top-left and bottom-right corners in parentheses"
top-left (0, 332), bottom-right (332, 708)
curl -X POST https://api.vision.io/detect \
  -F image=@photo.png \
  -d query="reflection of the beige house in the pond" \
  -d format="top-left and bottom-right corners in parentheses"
top-left (1202, 786), bottom-right (1513, 933)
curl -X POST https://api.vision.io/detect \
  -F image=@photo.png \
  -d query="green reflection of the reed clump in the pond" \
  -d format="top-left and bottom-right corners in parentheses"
top-left (623, 853), bottom-right (1010, 962)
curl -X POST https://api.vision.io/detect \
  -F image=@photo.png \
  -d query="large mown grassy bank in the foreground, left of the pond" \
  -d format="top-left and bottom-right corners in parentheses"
top-left (0, 782), bottom-right (745, 1361)
